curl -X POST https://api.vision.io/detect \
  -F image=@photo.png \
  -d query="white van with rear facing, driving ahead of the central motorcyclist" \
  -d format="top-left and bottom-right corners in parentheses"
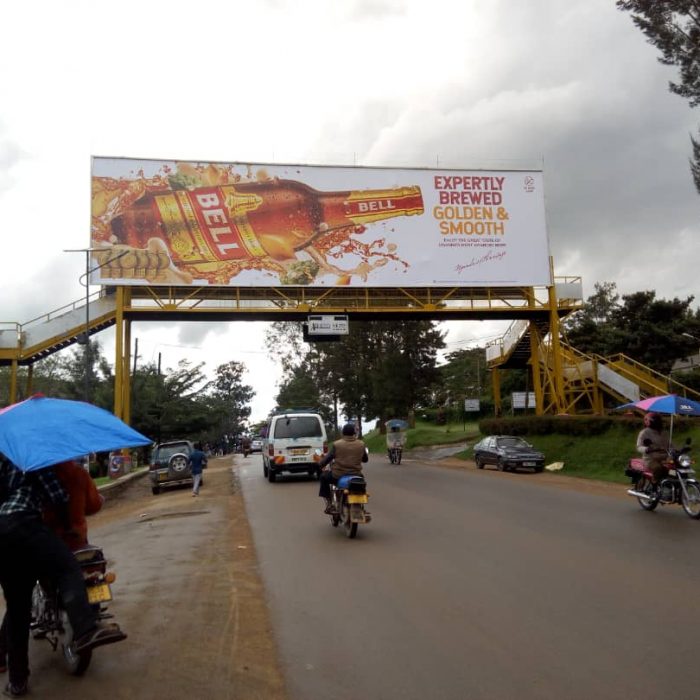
top-left (262, 411), bottom-right (328, 482)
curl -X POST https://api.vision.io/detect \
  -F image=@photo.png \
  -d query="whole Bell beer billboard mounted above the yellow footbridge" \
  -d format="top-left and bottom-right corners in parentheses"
top-left (90, 157), bottom-right (551, 287)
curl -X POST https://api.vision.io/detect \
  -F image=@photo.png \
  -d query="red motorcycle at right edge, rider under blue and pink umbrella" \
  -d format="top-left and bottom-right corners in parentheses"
top-left (625, 439), bottom-right (700, 520)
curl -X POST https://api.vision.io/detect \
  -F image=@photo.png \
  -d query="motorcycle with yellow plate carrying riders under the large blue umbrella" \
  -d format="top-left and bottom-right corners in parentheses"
top-left (30, 545), bottom-right (116, 676)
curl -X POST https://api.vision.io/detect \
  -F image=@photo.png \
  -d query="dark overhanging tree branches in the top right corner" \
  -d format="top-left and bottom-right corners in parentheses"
top-left (617, 0), bottom-right (700, 193)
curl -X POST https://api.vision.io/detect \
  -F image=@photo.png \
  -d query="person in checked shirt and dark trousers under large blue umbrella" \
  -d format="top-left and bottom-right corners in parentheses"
top-left (0, 454), bottom-right (126, 697)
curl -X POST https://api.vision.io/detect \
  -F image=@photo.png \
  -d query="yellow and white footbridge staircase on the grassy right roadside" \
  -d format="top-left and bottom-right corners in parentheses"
top-left (486, 321), bottom-right (700, 414)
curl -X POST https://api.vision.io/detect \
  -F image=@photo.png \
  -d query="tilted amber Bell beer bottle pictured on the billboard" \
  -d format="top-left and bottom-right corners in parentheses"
top-left (110, 180), bottom-right (423, 267)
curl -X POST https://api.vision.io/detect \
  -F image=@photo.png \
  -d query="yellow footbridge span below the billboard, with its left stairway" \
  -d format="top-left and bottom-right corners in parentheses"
top-left (0, 277), bottom-right (583, 422)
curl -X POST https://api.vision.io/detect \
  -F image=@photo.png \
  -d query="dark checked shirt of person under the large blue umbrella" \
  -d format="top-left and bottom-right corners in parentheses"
top-left (0, 459), bottom-right (68, 517)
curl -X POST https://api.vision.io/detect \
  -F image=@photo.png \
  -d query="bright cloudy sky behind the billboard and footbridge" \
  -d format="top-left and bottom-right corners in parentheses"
top-left (0, 0), bottom-right (700, 420)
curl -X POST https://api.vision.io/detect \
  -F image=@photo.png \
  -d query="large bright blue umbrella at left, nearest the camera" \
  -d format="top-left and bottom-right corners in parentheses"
top-left (0, 394), bottom-right (153, 472)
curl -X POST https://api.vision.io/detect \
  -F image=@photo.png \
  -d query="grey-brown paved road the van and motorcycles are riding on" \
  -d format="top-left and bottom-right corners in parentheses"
top-left (239, 456), bottom-right (700, 700)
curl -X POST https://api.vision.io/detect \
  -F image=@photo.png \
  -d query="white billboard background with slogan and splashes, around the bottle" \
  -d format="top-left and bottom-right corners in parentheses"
top-left (91, 157), bottom-right (551, 287)
